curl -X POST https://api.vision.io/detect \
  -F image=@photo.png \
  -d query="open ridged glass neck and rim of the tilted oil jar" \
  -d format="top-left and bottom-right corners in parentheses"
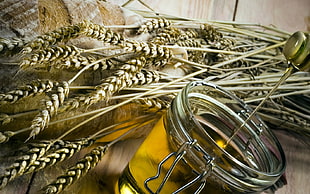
top-left (164, 82), bottom-right (285, 192)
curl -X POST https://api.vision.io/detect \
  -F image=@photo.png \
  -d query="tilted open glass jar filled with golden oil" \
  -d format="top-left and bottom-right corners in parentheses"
top-left (116, 81), bottom-right (285, 194)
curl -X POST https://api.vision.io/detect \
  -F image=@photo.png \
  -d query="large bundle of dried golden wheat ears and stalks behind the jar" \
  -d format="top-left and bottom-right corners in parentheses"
top-left (0, 2), bottom-right (310, 193)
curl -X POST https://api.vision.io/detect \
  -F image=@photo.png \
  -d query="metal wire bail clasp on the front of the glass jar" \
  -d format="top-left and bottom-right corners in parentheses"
top-left (144, 139), bottom-right (213, 194)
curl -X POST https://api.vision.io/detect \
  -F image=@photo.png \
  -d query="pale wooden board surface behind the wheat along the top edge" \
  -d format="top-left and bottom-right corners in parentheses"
top-left (113, 0), bottom-right (310, 32)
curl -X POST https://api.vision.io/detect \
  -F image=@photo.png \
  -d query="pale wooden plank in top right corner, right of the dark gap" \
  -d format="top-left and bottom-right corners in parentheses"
top-left (236, 0), bottom-right (310, 32)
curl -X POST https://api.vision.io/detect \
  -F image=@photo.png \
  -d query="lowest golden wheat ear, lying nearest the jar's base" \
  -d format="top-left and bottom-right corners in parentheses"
top-left (45, 146), bottom-right (108, 194)
